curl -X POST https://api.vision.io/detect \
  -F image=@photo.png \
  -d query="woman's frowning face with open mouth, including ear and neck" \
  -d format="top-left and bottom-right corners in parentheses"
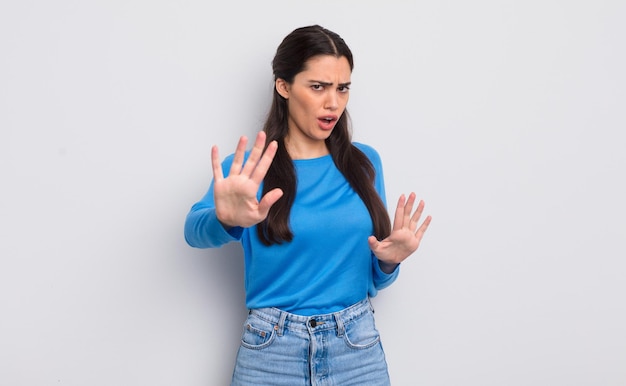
top-left (276, 55), bottom-right (351, 159)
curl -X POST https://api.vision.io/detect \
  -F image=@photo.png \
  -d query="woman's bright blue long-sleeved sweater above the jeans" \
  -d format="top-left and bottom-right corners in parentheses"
top-left (185, 143), bottom-right (399, 316)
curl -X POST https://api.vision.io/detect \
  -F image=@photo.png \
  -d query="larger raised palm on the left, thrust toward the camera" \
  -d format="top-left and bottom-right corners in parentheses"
top-left (211, 131), bottom-right (283, 228)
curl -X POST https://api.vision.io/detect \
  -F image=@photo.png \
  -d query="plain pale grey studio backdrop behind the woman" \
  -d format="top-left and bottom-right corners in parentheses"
top-left (0, 0), bottom-right (626, 386)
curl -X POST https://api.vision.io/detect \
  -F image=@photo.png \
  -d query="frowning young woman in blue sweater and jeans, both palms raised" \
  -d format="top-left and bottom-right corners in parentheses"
top-left (185, 25), bottom-right (431, 386)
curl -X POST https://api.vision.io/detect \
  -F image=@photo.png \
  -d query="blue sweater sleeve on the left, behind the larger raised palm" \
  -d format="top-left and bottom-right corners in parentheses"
top-left (184, 155), bottom-right (243, 248)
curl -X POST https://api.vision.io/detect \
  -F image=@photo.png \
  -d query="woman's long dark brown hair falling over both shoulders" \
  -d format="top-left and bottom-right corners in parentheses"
top-left (257, 25), bottom-right (391, 245)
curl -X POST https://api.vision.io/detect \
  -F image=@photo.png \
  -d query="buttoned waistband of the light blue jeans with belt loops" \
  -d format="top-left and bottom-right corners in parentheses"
top-left (250, 298), bottom-right (374, 336)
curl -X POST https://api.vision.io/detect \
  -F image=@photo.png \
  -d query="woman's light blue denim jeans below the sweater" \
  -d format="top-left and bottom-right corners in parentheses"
top-left (231, 299), bottom-right (390, 386)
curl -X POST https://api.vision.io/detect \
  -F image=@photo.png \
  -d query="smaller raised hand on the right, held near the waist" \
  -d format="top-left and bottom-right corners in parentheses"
top-left (367, 193), bottom-right (431, 273)
